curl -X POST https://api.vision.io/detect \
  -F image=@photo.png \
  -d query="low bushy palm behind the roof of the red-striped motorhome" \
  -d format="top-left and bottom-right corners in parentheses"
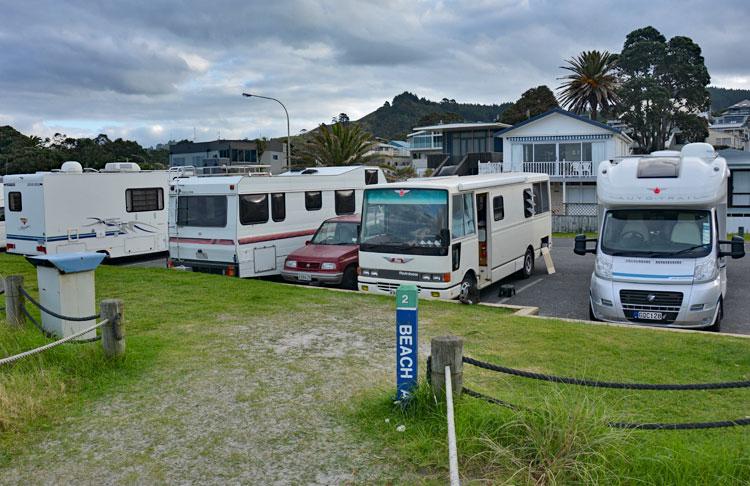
top-left (302, 123), bottom-right (374, 165)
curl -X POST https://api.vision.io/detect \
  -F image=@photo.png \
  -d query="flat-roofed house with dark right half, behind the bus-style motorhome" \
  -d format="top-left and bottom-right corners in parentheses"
top-left (407, 122), bottom-right (510, 176)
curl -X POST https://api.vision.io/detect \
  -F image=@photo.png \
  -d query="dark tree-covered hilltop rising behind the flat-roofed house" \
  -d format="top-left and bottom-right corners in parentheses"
top-left (357, 92), bottom-right (510, 140)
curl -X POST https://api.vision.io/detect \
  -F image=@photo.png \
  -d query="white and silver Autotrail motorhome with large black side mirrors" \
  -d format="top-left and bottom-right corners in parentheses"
top-left (575, 143), bottom-right (745, 330)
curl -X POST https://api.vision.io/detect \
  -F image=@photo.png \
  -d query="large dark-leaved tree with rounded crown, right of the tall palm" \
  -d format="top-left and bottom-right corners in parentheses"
top-left (618, 26), bottom-right (711, 152)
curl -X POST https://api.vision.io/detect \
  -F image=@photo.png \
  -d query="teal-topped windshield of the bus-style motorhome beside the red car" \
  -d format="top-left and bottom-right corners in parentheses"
top-left (360, 189), bottom-right (450, 255)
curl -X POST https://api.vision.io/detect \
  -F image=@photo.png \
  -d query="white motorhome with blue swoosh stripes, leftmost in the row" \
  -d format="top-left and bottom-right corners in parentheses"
top-left (4, 161), bottom-right (173, 258)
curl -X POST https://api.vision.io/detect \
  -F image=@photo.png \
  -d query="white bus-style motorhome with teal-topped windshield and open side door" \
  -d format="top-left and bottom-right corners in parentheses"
top-left (359, 172), bottom-right (552, 303)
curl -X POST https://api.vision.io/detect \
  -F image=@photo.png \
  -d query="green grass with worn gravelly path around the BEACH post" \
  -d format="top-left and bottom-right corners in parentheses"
top-left (0, 255), bottom-right (750, 484)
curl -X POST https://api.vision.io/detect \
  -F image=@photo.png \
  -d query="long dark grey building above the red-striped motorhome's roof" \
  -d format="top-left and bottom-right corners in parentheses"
top-left (169, 140), bottom-right (286, 174)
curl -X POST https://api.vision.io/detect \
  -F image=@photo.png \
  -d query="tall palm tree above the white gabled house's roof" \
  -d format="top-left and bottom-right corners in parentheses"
top-left (557, 51), bottom-right (619, 120)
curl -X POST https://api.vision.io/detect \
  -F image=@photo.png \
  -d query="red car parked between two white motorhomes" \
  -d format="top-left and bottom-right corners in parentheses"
top-left (281, 214), bottom-right (361, 290)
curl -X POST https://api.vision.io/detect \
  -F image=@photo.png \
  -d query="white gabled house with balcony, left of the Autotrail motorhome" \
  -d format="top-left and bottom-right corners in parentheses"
top-left (495, 108), bottom-right (633, 216)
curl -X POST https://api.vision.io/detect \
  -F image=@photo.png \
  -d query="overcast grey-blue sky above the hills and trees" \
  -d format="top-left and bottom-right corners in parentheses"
top-left (0, 0), bottom-right (750, 145)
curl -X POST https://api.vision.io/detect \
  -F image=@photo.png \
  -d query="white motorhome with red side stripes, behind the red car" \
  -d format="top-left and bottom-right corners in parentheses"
top-left (168, 167), bottom-right (385, 277)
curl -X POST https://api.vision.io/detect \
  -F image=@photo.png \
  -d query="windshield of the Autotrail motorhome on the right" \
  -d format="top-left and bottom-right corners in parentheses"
top-left (601, 209), bottom-right (712, 258)
